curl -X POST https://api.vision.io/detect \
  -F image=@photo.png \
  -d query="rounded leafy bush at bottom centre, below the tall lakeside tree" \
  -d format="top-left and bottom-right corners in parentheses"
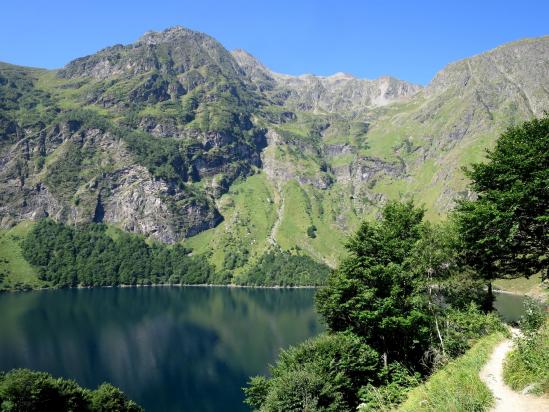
top-left (245, 333), bottom-right (380, 411)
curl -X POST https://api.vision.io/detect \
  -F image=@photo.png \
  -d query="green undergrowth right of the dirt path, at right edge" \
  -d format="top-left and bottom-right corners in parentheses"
top-left (503, 316), bottom-right (549, 395)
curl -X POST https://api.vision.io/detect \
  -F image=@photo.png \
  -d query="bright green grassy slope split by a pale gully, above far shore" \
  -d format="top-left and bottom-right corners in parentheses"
top-left (184, 173), bottom-right (358, 274)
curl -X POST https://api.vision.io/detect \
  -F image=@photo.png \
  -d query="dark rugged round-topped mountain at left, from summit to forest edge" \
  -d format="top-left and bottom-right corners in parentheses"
top-left (0, 27), bottom-right (265, 243)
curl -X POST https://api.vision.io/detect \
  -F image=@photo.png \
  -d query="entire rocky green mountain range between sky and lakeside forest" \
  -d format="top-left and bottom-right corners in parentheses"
top-left (0, 27), bottom-right (549, 281)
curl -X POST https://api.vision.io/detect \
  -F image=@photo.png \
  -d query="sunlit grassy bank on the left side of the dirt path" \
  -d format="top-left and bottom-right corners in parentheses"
top-left (397, 333), bottom-right (504, 412)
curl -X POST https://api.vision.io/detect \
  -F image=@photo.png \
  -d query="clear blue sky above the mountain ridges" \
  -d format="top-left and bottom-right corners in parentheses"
top-left (0, 0), bottom-right (549, 84)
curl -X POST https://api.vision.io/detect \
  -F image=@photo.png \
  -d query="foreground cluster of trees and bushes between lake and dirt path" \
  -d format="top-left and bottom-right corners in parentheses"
top-left (245, 201), bottom-right (502, 411)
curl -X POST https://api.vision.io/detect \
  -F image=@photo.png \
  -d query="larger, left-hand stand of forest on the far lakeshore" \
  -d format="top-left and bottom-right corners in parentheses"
top-left (22, 219), bottom-right (214, 287)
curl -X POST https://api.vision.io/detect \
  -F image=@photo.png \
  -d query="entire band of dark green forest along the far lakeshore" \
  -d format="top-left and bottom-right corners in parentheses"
top-left (21, 219), bottom-right (329, 287)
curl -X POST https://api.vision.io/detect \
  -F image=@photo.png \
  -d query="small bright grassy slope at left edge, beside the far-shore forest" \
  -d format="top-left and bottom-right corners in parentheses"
top-left (0, 221), bottom-right (45, 290)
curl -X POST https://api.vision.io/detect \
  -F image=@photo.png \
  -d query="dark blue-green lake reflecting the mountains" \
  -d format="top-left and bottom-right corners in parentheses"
top-left (0, 287), bottom-right (323, 412)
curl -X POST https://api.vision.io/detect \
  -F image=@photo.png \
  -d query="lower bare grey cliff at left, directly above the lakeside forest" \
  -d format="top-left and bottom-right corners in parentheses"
top-left (0, 116), bottom-right (222, 243)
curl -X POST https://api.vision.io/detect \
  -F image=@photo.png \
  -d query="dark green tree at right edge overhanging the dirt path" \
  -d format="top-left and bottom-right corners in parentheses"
top-left (455, 116), bottom-right (549, 307)
